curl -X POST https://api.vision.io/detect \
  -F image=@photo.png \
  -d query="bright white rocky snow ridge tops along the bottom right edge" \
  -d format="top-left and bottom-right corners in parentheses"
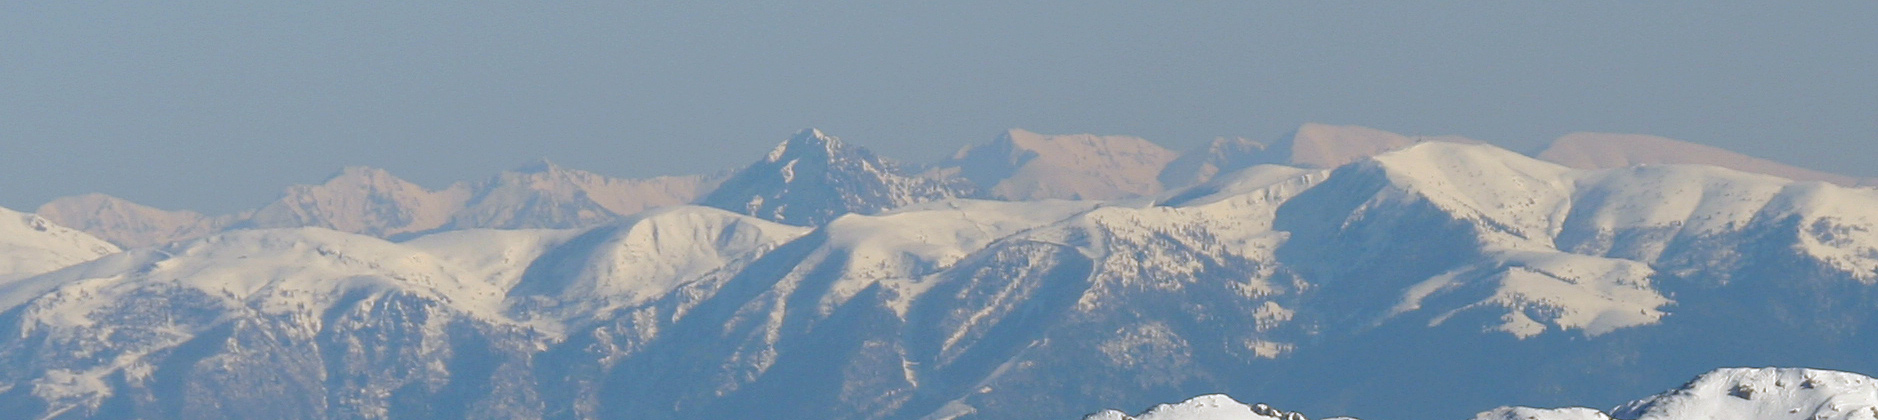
top-left (1084, 368), bottom-right (1878, 420)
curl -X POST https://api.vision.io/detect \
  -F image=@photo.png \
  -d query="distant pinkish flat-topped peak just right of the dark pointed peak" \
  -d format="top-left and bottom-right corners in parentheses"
top-left (935, 129), bottom-right (1176, 201)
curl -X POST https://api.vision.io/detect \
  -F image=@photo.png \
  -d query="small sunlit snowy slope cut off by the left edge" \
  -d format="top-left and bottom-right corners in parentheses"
top-left (0, 208), bottom-right (118, 285)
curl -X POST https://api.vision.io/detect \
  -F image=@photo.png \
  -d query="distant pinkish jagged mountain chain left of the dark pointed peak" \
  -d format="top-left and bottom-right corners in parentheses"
top-left (39, 159), bottom-right (721, 248)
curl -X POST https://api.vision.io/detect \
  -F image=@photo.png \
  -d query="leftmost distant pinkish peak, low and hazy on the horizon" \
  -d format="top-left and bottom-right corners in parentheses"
top-left (36, 193), bottom-right (244, 248)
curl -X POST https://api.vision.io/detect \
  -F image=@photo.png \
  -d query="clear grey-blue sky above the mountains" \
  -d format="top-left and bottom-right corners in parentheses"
top-left (0, 0), bottom-right (1878, 214)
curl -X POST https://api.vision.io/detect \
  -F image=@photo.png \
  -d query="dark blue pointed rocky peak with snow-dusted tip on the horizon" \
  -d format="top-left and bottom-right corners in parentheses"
top-left (699, 129), bottom-right (975, 225)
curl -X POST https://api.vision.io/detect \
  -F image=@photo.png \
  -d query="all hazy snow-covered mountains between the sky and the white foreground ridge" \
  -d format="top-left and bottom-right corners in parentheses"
top-left (0, 124), bottom-right (1878, 420)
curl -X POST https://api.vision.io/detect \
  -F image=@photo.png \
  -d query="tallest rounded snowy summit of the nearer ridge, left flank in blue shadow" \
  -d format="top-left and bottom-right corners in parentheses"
top-left (1279, 143), bottom-right (1670, 339)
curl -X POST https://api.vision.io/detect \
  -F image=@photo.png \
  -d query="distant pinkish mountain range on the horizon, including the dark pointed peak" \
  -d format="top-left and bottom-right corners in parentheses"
top-left (36, 124), bottom-right (1878, 248)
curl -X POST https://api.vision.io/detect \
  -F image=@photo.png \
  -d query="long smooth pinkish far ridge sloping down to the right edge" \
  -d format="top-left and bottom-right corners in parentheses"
top-left (1538, 133), bottom-right (1878, 186)
